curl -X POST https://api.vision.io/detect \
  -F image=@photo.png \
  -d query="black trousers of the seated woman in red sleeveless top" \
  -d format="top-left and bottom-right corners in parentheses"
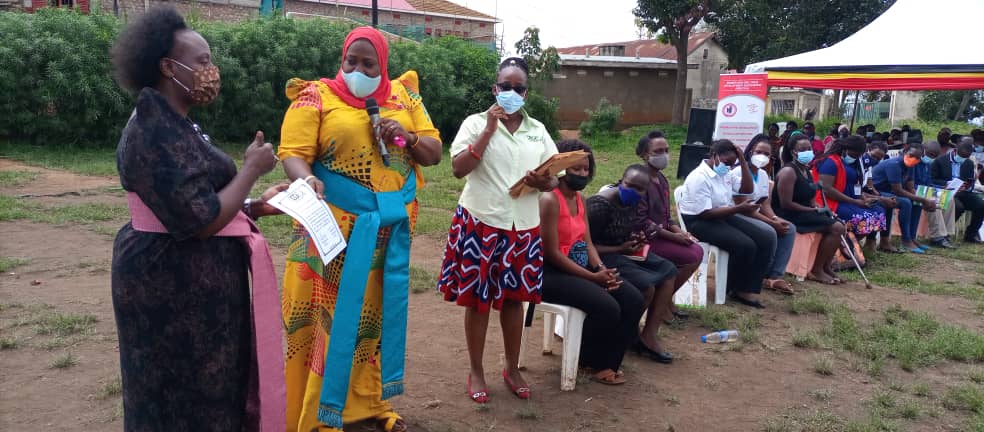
top-left (542, 264), bottom-right (646, 371)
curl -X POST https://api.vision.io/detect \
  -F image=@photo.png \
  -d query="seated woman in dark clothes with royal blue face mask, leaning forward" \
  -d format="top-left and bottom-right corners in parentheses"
top-left (587, 164), bottom-right (677, 363)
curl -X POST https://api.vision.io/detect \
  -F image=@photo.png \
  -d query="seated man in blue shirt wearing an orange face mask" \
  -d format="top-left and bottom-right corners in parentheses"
top-left (871, 143), bottom-right (936, 254)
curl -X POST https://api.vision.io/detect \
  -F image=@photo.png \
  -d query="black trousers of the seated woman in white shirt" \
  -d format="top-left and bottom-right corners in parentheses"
top-left (683, 215), bottom-right (777, 293)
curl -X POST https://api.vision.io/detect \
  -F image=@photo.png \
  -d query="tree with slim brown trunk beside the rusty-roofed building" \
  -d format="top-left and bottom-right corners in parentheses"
top-left (632, 0), bottom-right (729, 124)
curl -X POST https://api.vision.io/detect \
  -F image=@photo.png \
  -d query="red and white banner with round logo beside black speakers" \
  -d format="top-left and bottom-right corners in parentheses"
top-left (714, 73), bottom-right (769, 149)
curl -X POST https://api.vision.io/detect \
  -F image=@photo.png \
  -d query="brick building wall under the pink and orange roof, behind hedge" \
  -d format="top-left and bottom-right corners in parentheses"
top-left (284, 0), bottom-right (495, 43)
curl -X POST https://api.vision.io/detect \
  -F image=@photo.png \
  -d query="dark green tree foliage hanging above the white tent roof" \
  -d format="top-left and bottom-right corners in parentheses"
top-left (715, 0), bottom-right (895, 70)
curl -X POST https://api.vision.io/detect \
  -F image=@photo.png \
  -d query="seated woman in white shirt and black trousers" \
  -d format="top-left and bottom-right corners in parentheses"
top-left (677, 140), bottom-right (776, 308)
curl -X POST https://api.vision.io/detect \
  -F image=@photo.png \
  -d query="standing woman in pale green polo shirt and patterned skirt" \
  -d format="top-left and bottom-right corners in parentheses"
top-left (438, 57), bottom-right (557, 404)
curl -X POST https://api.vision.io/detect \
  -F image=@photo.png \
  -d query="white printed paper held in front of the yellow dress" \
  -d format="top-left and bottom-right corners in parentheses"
top-left (268, 179), bottom-right (346, 265)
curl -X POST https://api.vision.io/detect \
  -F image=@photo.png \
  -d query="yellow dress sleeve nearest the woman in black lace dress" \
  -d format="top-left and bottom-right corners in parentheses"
top-left (277, 78), bottom-right (322, 164)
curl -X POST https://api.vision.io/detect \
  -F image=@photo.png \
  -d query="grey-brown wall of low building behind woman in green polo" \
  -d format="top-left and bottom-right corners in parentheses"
top-left (543, 66), bottom-right (676, 129)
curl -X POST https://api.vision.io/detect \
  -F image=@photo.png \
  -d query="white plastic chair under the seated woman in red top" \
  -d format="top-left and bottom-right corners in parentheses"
top-left (519, 303), bottom-right (587, 391)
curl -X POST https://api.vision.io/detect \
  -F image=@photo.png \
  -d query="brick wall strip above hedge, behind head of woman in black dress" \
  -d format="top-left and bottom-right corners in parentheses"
top-left (99, 0), bottom-right (260, 21)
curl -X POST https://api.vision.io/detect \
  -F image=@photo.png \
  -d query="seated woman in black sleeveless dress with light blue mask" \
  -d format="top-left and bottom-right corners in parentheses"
top-left (772, 135), bottom-right (844, 284)
